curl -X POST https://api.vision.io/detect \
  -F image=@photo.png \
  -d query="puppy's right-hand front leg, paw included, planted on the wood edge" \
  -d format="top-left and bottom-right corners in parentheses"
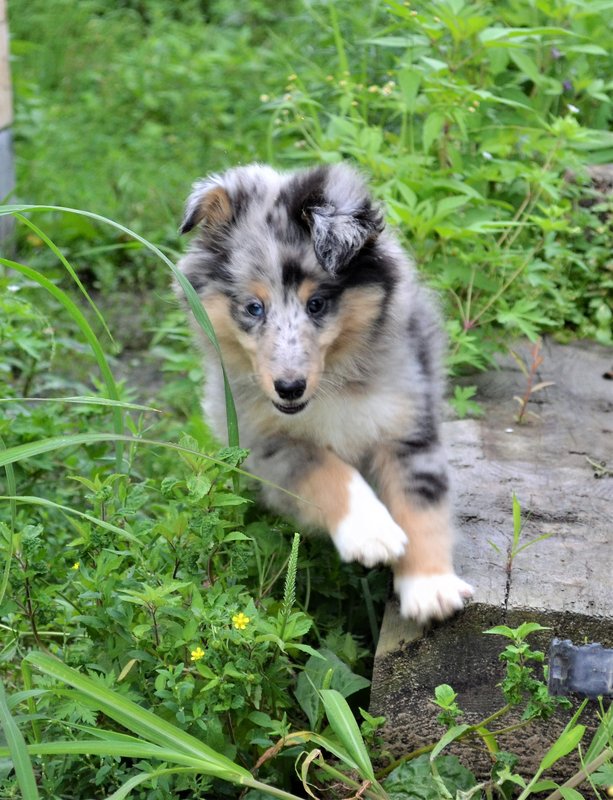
top-left (374, 438), bottom-right (473, 623)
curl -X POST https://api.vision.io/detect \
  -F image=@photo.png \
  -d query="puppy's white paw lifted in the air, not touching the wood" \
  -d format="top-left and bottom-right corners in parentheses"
top-left (332, 473), bottom-right (407, 567)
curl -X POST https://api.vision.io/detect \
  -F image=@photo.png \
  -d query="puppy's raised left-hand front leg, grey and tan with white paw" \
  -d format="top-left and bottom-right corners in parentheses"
top-left (251, 442), bottom-right (407, 567)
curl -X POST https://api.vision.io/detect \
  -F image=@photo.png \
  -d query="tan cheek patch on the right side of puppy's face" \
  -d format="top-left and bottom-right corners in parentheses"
top-left (326, 286), bottom-right (383, 359)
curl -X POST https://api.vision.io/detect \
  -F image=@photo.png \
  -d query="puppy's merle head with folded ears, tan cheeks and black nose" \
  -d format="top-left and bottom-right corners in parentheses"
top-left (179, 164), bottom-right (394, 414)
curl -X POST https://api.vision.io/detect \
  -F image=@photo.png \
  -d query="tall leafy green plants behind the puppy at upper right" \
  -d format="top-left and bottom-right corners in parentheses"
top-left (265, 0), bottom-right (613, 371)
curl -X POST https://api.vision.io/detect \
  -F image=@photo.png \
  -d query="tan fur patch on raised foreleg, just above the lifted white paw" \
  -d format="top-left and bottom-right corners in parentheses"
top-left (296, 450), bottom-right (353, 531)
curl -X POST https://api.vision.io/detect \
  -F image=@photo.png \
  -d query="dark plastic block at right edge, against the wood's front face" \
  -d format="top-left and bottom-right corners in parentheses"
top-left (549, 639), bottom-right (613, 698)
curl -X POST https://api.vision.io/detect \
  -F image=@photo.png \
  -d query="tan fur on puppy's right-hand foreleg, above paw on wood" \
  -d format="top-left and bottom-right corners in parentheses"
top-left (375, 449), bottom-right (453, 575)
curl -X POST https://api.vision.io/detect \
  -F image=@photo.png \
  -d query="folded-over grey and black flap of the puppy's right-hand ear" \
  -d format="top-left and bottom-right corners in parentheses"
top-left (309, 200), bottom-right (384, 277)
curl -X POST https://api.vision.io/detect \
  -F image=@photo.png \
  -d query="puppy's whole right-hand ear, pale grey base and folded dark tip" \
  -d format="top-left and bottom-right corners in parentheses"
top-left (305, 167), bottom-right (385, 277)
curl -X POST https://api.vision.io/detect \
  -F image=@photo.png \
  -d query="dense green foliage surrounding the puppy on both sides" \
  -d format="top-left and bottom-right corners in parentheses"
top-left (0, 0), bottom-right (613, 800)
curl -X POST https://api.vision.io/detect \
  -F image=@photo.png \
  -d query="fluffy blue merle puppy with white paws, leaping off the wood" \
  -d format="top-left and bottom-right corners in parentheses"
top-left (179, 164), bottom-right (472, 623)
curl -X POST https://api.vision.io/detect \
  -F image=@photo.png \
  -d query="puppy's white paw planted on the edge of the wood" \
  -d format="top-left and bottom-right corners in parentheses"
top-left (394, 572), bottom-right (473, 624)
